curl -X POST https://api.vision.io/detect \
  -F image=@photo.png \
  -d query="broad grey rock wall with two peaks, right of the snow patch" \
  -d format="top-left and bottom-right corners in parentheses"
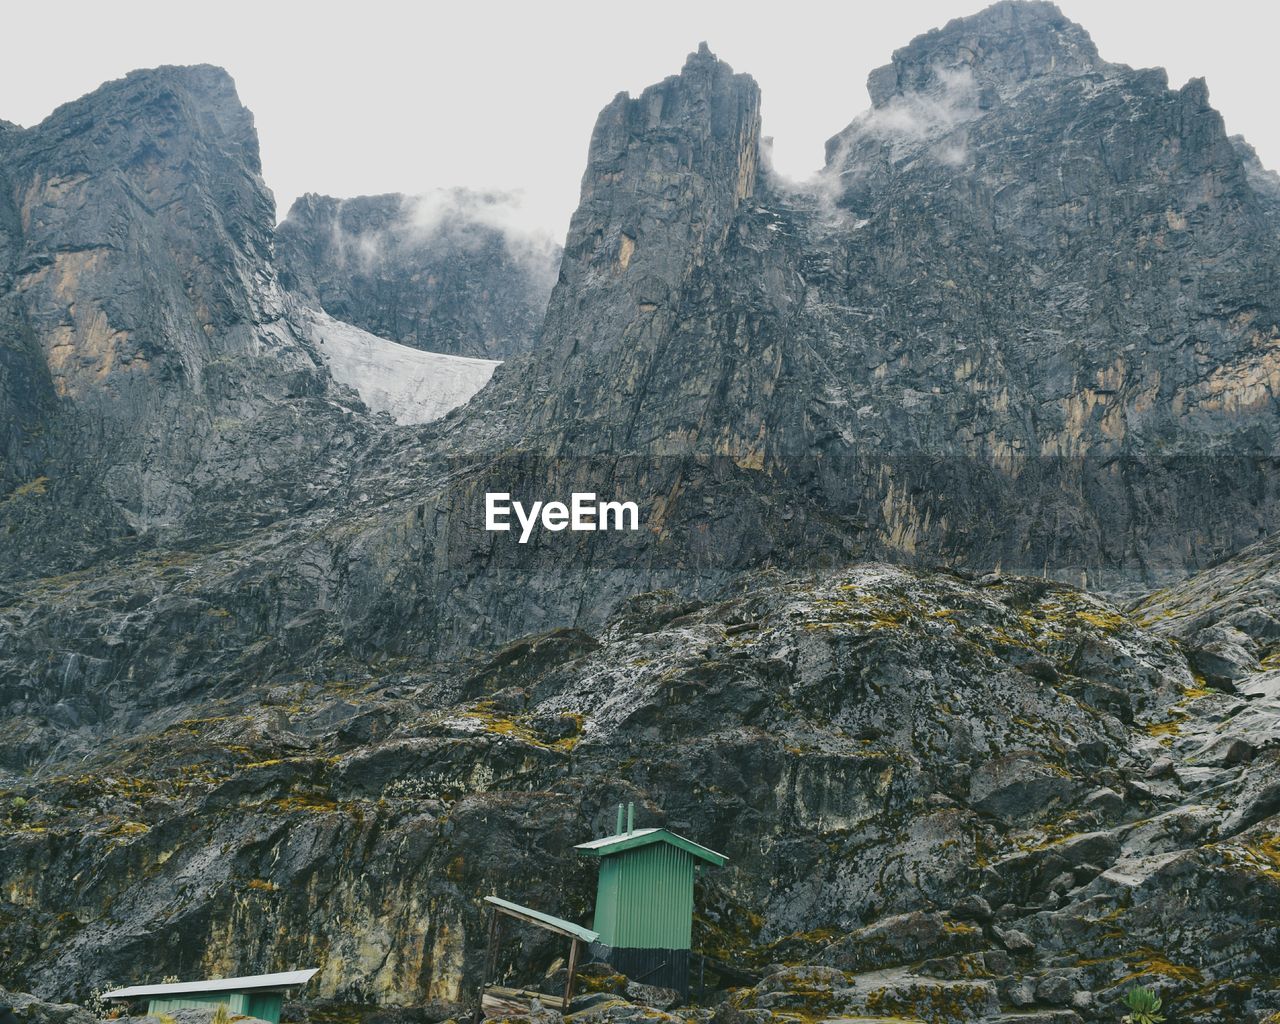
top-left (12, 5), bottom-right (1277, 686)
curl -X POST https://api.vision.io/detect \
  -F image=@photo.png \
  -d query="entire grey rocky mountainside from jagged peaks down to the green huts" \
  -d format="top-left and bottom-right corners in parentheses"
top-left (0, 3), bottom-right (1280, 1024)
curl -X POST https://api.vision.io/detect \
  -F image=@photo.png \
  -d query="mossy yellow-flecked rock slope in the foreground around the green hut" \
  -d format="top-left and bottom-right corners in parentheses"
top-left (0, 562), bottom-right (1280, 1021)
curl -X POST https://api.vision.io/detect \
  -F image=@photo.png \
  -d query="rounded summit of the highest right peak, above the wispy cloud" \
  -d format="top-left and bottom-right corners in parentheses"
top-left (867, 0), bottom-right (1103, 108)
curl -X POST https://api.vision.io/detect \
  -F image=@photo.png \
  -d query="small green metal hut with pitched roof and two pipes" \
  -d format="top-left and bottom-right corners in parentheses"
top-left (573, 805), bottom-right (728, 995)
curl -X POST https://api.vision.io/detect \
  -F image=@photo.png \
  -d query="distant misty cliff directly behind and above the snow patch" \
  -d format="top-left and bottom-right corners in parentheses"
top-left (275, 188), bottom-right (561, 360)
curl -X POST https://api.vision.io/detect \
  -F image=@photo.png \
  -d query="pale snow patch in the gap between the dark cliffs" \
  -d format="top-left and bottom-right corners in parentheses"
top-left (302, 310), bottom-right (500, 424)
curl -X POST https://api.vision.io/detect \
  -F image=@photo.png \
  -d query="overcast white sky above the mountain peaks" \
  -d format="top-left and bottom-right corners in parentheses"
top-left (0, 0), bottom-right (1280, 237)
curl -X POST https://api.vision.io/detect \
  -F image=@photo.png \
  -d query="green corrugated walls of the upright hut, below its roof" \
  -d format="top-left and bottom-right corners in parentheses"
top-left (595, 842), bottom-right (694, 950)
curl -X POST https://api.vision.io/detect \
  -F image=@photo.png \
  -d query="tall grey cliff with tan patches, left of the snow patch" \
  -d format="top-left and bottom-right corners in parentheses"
top-left (0, 67), bottom-right (373, 573)
